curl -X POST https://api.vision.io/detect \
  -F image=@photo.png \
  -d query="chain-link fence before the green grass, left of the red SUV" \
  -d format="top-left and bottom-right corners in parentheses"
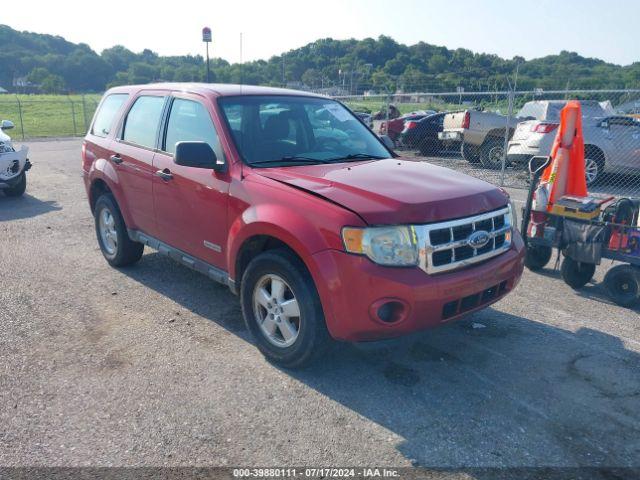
top-left (0, 95), bottom-right (100, 140)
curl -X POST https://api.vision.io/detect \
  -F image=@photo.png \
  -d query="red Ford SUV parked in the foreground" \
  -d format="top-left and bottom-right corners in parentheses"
top-left (82, 84), bottom-right (523, 367)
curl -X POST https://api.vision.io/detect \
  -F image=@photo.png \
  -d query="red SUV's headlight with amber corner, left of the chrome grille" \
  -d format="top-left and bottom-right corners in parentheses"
top-left (342, 226), bottom-right (418, 267)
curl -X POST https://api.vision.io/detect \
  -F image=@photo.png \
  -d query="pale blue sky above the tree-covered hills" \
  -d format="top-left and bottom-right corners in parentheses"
top-left (10, 0), bottom-right (640, 65)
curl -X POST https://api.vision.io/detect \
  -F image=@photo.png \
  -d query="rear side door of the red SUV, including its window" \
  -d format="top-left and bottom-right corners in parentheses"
top-left (111, 91), bottom-right (167, 236)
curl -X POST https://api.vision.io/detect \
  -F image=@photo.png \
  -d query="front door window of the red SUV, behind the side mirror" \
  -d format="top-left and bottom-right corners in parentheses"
top-left (163, 98), bottom-right (224, 160)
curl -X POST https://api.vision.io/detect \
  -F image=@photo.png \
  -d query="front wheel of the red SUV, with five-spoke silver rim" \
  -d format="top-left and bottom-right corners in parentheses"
top-left (240, 249), bottom-right (330, 368)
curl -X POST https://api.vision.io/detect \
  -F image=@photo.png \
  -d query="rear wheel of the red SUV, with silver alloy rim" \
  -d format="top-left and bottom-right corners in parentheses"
top-left (94, 193), bottom-right (144, 267)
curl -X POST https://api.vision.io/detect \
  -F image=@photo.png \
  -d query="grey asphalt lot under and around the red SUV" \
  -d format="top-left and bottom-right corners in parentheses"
top-left (0, 140), bottom-right (640, 470)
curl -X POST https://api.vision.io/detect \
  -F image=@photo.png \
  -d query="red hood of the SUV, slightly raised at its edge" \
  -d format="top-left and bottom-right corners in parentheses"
top-left (254, 159), bottom-right (508, 225)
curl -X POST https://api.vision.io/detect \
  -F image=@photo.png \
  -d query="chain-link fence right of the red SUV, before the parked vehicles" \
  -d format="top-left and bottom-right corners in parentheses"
top-left (336, 90), bottom-right (640, 196)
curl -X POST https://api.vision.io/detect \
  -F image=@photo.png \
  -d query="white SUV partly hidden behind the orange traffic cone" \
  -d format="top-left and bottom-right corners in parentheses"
top-left (507, 100), bottom-right (640, 185)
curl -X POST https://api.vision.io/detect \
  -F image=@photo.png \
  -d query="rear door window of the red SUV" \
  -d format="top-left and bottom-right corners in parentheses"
top-left (122, 95), bottom-right (165, 148)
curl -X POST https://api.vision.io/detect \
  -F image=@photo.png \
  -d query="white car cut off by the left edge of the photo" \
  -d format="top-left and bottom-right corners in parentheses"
top-left (0, 120), bottom-right (31, 197)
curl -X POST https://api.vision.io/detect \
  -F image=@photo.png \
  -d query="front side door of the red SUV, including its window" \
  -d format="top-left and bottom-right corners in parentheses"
top-left (153, 93), bottom-right (231, 270)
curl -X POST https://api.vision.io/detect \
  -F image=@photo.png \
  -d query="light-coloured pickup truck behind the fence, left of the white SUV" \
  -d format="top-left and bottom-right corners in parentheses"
top-left (438, 110), bottom-right (519, 169)
